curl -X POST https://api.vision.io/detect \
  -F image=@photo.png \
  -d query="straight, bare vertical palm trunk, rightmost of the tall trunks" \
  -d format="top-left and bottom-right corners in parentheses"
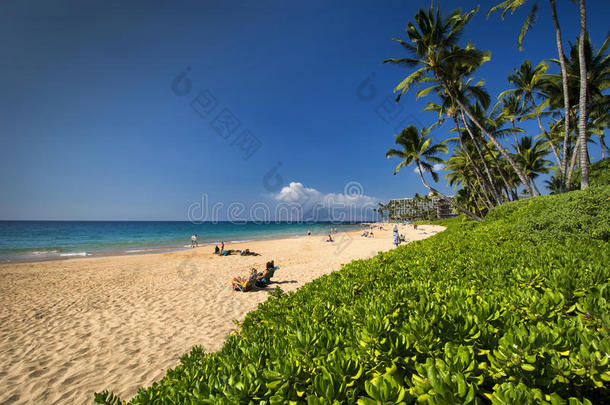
top-left (578, 0), bottom-right (589, 190)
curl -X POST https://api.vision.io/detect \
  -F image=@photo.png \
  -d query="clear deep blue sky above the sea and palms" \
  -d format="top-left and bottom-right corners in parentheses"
top-left (0, 0), bottom-right (610, 220)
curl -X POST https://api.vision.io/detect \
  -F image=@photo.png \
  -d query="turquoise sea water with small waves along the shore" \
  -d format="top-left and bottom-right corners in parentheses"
top-left (0, 221), bottom-right (357, 263)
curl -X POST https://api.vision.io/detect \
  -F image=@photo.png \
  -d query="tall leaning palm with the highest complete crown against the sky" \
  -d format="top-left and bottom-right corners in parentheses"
top-left (384, 6), bottom-right (534, 195)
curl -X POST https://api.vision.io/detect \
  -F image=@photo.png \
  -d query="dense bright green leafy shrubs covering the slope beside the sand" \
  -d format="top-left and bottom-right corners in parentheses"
top-left (96, 187), bottom-right (610, 405)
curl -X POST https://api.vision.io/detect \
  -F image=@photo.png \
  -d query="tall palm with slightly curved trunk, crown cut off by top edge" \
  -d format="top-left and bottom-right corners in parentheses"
top-left (487, 0), bottom-right (570, 191)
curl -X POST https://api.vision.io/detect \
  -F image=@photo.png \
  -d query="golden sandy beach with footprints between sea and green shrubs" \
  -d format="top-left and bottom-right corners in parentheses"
top-left (0, 225), bottom-right (443, 404)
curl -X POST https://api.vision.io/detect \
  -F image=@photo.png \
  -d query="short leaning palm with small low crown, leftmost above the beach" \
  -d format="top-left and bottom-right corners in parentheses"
top-left (386, 125), bottom-right (481, 221)
